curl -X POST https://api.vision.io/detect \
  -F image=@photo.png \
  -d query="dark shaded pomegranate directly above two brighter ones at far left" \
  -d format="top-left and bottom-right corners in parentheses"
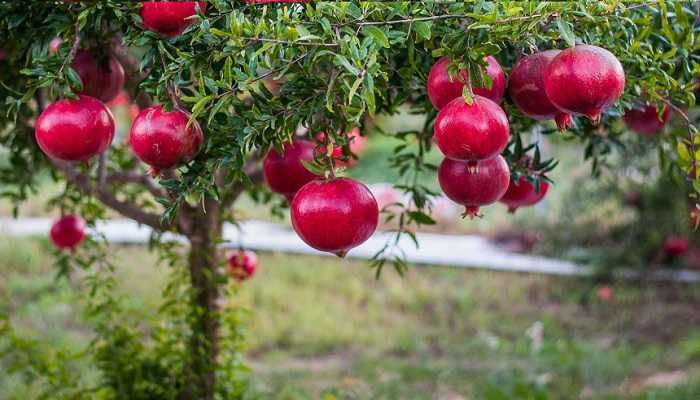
top-left (71, 50), bottom-right (124, 103)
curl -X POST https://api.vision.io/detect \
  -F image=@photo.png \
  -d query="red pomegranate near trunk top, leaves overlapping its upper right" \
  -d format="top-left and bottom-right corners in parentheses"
top-left (129, 106), bottom-right (204, 175)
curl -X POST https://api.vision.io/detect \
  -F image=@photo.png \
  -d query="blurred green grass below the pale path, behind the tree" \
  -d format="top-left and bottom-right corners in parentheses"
top-left (0, 238), bottom-right (700, 400)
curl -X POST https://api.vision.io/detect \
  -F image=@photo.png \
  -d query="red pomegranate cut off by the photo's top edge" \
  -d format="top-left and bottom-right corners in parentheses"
top-left (141, 1), bottom-right (207, 38)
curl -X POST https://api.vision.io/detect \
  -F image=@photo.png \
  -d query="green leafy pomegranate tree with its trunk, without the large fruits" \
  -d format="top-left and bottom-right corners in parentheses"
top-left (0, 0), bottom-right (700, 399)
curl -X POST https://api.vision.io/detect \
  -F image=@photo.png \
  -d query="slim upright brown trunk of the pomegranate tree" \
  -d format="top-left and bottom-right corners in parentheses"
top-left (180, 199), bottom-right (222, 400)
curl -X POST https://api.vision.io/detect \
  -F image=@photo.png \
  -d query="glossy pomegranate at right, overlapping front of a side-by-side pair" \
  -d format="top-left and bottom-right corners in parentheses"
top-left (544, 45), bottom-right (625, 122)
